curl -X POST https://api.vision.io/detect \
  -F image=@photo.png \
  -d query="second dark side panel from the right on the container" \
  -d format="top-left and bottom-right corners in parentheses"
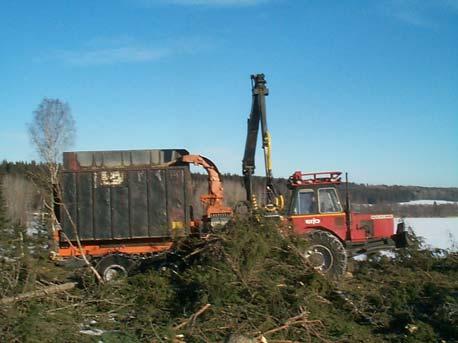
top-left (148, 169), bottom-right (170, 237)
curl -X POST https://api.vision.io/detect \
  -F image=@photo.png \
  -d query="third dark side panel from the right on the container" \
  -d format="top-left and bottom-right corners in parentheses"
top-left (129, 170), bottom-right (148, 238)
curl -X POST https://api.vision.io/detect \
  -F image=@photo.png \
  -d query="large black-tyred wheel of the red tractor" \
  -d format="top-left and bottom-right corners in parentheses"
top-left (304, 230), bottom-right (347, 279)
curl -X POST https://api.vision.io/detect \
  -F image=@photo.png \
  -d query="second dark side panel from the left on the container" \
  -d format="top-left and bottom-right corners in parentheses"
top-left (76, 173), bottom-right (94, 239)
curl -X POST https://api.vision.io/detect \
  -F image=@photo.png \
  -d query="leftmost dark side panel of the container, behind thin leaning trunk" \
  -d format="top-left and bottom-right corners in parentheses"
top-left (60, 173), bottom-right (77, 241)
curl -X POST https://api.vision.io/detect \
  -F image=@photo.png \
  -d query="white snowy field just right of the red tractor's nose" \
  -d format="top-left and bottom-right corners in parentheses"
top-left (405, 217), bottom-right (458, 249)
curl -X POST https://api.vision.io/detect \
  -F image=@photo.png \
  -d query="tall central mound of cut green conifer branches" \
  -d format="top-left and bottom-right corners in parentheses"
top-left (101, 220), bottom-right (332, 342)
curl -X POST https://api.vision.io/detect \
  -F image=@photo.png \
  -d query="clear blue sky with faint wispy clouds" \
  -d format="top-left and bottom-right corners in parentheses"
top-left (0, 0), bottom-right (458, 187)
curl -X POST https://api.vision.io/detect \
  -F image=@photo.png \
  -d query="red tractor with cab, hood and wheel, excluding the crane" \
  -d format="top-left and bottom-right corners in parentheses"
top-left (286, 172), bottom-right (407, 276)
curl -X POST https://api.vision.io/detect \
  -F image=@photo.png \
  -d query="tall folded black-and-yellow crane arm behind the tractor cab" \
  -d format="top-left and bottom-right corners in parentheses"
top-left (242, 74), bottom-right (279, 207)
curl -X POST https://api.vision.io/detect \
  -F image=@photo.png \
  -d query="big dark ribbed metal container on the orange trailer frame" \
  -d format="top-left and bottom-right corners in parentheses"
top-left (60, 150), bottom-right (192, 241)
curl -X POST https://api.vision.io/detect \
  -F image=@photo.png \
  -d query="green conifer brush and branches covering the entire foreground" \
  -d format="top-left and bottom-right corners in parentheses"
top-left (0, 219), bottom-right (458, 343)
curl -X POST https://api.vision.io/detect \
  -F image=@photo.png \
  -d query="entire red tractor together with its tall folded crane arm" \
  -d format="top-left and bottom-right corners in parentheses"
top-left (243, 74), bottom-right (407, 278)
